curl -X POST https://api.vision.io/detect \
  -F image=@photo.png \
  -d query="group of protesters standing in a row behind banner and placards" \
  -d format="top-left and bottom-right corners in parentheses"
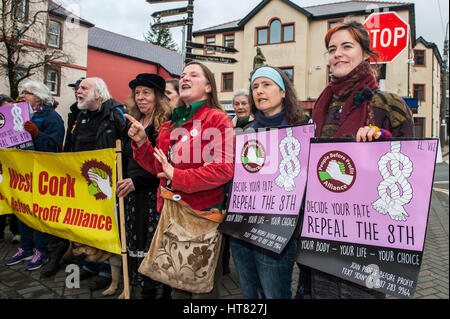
top-left (0, 21), bottom-right (413, 299)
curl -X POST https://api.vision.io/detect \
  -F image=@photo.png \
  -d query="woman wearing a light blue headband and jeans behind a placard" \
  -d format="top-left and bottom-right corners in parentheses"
top-left (230, 66), bottom-right (308, 299)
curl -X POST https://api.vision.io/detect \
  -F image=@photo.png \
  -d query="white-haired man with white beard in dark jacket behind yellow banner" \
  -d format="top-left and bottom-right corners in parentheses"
top-left (68, 78), bottom-right (127, 290)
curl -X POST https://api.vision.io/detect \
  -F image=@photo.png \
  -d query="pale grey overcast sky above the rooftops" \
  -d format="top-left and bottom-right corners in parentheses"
top-left (61, 0), bottom-right (449, 54)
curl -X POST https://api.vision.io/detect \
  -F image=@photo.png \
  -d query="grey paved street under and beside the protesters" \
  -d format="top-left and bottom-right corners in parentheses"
top-left (0, 146), bottom-right (449, 299)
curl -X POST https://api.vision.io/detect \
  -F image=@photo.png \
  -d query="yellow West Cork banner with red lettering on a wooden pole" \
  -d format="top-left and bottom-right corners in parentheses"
top-left (0, 149), bottom-right (121, 254)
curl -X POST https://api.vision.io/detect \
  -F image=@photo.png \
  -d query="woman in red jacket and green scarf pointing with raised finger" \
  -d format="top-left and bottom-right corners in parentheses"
top-left (127, 62), bottom-right (234, 298)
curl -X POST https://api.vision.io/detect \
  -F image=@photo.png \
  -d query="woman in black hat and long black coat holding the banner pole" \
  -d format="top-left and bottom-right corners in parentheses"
top-left (117, 73), bottom-right (170, 299)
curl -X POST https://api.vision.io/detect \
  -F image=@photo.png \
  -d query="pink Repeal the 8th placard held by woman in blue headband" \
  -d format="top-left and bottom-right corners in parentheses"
top-left (219, 124), bottom-right (314, 253)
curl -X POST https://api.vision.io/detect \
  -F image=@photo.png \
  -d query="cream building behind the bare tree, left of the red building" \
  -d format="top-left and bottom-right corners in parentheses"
top-left (0, 0), bottom-right (94, 130)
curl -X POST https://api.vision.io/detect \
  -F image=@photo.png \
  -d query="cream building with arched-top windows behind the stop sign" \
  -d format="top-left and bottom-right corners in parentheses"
top-left (193, 0), bottom-right (442, 137)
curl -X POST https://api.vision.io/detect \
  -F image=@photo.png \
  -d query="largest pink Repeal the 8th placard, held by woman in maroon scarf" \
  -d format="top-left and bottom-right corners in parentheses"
top-left (296, 139), bottom-right (438, 298)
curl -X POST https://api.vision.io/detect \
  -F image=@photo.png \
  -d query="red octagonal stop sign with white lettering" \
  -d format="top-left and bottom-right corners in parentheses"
top-left (364, 12), bottom-right (409, 63)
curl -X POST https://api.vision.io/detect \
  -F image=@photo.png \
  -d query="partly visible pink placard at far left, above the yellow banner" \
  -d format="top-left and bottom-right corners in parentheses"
top-left (0, 102), bottom-right (33, 149)
